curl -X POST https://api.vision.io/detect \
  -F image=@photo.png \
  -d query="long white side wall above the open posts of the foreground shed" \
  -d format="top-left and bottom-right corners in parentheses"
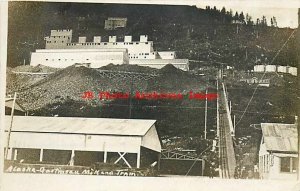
top-left (6, 132), bottom-right (141, 153)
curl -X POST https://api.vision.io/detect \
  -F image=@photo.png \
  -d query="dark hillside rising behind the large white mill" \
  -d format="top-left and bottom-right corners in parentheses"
top-left (8, 2), bottom-right (297, 69)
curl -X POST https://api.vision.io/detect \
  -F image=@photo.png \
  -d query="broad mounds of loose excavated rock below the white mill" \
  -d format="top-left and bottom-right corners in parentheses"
top-left (7, 65), bottom-right (213, 110)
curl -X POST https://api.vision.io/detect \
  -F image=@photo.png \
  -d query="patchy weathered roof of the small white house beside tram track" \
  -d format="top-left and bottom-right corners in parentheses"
top-left (261, 123), bottom-right (298, 152)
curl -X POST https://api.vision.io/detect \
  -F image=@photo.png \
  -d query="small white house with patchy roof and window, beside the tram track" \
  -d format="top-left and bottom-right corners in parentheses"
top-left (259, 123), bottom-right (298, 180)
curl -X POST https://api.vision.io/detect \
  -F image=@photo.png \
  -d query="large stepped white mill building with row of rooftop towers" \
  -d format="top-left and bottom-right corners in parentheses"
top-left (30, 30), bottom-right (189, 70)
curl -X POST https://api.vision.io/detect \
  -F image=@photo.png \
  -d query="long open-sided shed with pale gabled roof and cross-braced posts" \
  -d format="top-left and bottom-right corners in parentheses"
top-left (5, 116), bottom-right (161, 168)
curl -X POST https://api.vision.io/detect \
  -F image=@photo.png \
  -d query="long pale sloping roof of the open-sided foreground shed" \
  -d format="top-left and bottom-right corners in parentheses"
top-left (5, 116), bottom-right (156, 136)
